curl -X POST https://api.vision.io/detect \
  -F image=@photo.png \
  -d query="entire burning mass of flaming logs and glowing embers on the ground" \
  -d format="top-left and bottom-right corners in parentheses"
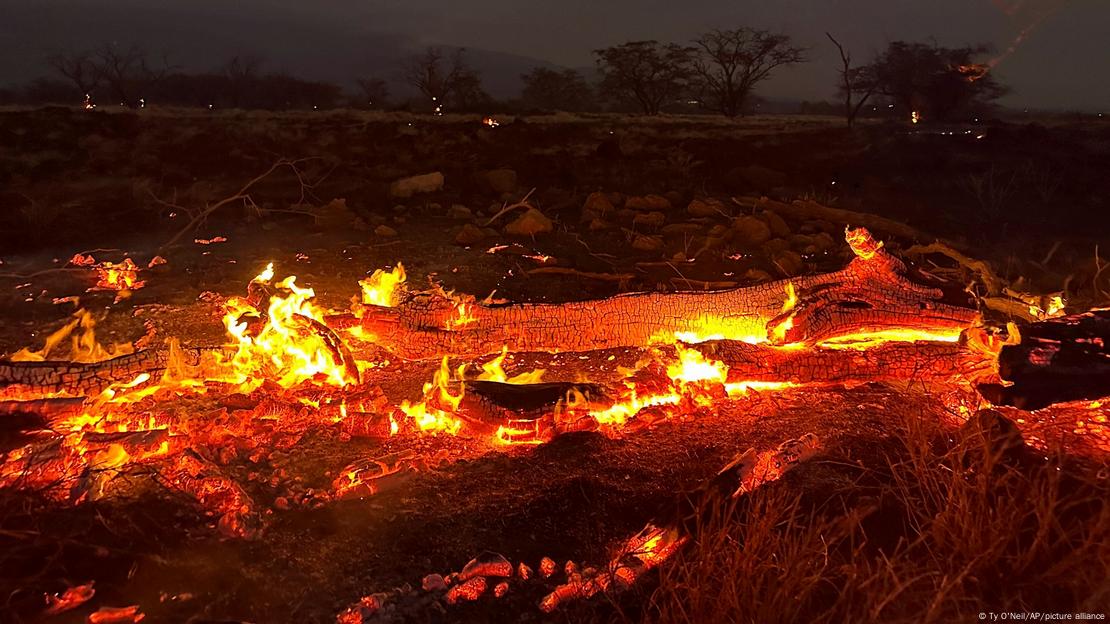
top-left (0, 222), bottom-right (1110, 622)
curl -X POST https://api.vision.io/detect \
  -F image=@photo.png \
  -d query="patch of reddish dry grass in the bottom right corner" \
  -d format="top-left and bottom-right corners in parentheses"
top-left (625, 413), bottom-right (1110, 623)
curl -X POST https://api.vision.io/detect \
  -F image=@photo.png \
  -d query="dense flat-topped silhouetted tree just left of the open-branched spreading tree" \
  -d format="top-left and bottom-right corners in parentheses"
top-left (594, 41), bottom-right (693, 114)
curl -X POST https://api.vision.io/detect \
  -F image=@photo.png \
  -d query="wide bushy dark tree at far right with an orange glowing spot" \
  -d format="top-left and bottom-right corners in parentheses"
top-left (865, 41), bottom-right (1006, 121)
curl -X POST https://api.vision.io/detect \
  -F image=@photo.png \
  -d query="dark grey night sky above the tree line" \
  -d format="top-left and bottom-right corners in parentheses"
top-left (0, 0), bottom-right (1110, 110)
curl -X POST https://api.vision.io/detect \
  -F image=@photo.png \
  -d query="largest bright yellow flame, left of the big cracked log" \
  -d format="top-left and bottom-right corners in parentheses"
top-left (217, 263), bottom-right (357, 389)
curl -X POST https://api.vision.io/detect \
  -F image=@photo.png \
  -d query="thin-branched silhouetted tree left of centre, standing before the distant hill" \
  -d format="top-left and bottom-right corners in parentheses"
top-left (402, 48), bottom-right (488, 112)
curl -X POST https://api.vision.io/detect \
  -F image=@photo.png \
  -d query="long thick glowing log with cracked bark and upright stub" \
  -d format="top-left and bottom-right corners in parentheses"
top-left (350, 230), bottom-right (979, 359)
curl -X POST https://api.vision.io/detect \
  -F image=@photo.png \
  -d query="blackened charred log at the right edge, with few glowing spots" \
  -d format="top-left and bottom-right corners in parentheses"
top-left (988, 310), bottom-right (1110, 410)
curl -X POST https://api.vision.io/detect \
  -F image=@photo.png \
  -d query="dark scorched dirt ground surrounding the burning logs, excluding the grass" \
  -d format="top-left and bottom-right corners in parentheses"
top-left (0, 109), bottom-right (1110, 622)
